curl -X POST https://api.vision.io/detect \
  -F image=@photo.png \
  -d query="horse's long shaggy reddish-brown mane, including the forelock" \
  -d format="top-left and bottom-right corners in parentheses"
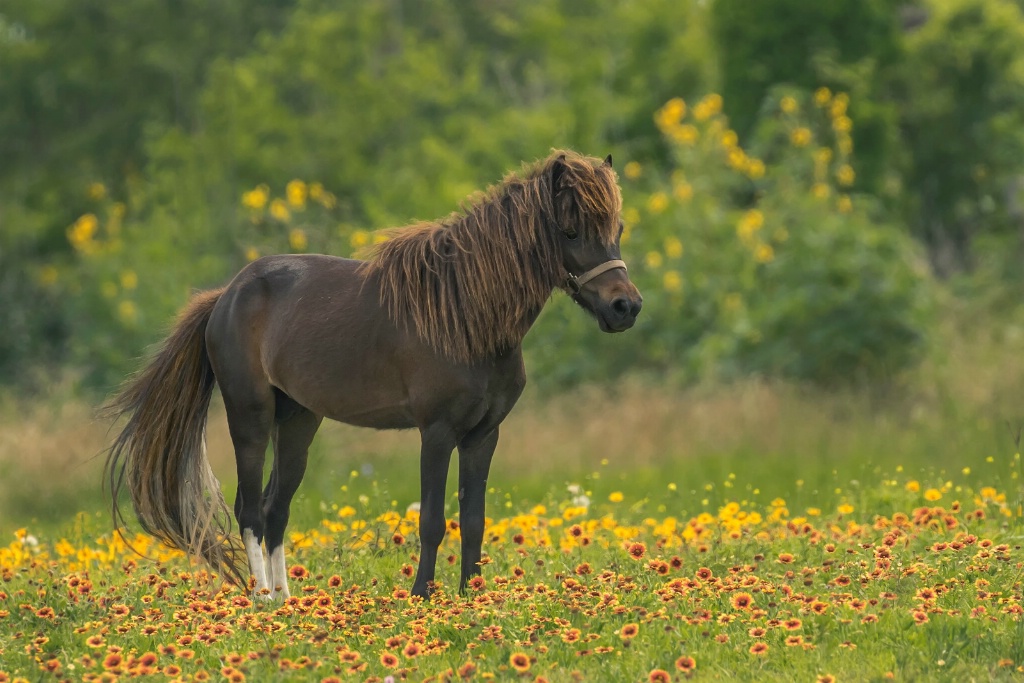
top-left (362, 151), bottom-right (622, 362)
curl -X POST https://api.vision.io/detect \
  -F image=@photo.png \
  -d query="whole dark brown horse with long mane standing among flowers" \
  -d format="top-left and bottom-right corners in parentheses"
top-left (106, 152), bottom-right (642, 599)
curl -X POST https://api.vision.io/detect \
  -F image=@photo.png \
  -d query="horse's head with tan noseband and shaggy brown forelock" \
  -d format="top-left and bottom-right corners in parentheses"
top-left (550, 155), bottom-right (643, 332)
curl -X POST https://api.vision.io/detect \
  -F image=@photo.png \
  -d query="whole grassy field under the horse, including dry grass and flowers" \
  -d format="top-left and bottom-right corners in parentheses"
top-left (0, 311), bottom-right (1024, 681)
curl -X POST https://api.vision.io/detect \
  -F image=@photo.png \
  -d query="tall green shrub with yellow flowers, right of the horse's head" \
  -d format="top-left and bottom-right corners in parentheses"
top-left (530, 93), bottom-right (929, 382)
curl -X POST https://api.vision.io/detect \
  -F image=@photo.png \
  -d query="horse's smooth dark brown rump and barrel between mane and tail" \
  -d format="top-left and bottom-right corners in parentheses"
top-left (207, 255), bottom-right (415, 428)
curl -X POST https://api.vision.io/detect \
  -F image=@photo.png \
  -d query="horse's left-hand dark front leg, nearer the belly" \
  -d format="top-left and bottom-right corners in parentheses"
top-left (413, 424), bottom-right (455, 598)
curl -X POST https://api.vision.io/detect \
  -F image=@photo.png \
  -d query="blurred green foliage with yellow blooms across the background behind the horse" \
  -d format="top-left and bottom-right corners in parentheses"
top-left (0, 0), bottom-right (1024, 386)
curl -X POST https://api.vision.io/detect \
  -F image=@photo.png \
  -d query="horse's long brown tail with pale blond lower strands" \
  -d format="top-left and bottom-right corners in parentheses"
top-left (106, 290), bottom-right (245, 585)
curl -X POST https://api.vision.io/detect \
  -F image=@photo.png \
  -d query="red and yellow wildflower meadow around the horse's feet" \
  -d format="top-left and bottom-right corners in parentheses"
top-left (0, 456), bottom-right (1024, 682)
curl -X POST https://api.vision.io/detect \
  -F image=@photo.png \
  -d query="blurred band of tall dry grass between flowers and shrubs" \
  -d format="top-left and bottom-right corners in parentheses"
top-left (6, 301), bottom-right (1024, 537)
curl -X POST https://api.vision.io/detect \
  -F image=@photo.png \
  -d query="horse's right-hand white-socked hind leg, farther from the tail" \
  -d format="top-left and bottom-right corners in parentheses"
top-left (263, 394), bottom-right (323, 600)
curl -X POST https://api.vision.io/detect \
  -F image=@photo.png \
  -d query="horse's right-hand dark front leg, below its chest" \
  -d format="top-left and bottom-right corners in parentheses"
top-left (459, 427), bottom-right (498, 592)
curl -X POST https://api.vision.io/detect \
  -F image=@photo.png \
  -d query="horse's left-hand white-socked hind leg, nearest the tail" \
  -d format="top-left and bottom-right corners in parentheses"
top-left (218, 385), bottom-right (274, 595)
